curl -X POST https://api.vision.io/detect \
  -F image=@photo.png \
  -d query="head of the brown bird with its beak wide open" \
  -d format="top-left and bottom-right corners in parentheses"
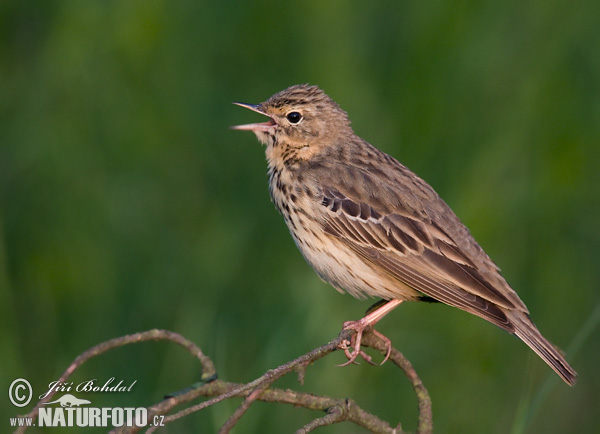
top-left (231, 84), bottom-right (352, 152)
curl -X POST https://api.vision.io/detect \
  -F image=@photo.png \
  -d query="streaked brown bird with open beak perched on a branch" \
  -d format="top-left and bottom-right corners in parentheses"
top-left (231, 84), bottom-right (577, 386)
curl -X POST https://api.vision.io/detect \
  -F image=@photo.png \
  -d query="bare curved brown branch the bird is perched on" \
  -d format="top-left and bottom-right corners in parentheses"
top-left (17, 329), bottom-right (433, 434)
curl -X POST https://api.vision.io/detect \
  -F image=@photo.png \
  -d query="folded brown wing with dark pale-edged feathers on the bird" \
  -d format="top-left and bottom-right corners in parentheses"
top-left (322, 188), bottom-right (524, 332)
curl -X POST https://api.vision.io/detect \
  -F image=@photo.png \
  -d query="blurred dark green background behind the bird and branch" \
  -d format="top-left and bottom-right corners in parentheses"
top-left (0, 0), bottom-right (600, 433)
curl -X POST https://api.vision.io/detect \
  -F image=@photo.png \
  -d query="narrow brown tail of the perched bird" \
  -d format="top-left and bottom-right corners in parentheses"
top-left (510, 311), bottom-right (577, 386)
